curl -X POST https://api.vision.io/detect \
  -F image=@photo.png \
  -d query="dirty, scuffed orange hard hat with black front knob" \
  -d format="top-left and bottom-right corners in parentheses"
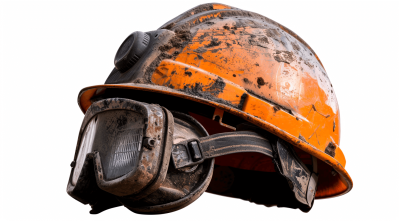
top-left (78, 4), bottom-right (353, 202)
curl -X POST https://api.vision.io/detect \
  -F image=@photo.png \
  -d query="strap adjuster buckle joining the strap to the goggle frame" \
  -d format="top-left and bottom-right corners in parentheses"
top-left (171, 139), bottom-right (204, 169)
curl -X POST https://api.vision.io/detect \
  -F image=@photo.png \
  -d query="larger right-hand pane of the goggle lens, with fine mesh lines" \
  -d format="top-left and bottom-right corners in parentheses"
top-left (93, 110), bottom-right (144, 180)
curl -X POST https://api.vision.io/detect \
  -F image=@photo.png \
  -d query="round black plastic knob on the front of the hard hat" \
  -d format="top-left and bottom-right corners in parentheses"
top-left (114, 31), bottom-right (150, 72)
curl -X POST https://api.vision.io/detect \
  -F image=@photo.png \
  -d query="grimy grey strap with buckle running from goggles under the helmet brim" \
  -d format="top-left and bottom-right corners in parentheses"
top-left (171, 131), bottom-right (318, 209)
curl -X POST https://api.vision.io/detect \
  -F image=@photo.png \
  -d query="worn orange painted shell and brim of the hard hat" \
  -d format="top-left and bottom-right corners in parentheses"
top-left (78, 4), bottom-right (353, 198)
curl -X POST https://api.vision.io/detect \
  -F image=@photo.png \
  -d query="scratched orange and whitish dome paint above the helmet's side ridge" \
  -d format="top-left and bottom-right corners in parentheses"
top-left (175, 18), bottom-right (338, 116)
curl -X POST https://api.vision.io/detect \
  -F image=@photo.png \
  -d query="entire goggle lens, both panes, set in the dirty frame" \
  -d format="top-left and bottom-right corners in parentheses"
top-left (72, 110), bottom-right (144, 185)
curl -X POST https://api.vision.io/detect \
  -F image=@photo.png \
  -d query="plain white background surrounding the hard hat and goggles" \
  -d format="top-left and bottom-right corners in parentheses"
top-left (0, 0), bottom-right (400, 224)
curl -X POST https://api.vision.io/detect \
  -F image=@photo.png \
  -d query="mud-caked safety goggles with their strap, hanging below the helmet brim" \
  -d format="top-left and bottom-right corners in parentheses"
top-left (67, 98), bottom-right (318, 214)
